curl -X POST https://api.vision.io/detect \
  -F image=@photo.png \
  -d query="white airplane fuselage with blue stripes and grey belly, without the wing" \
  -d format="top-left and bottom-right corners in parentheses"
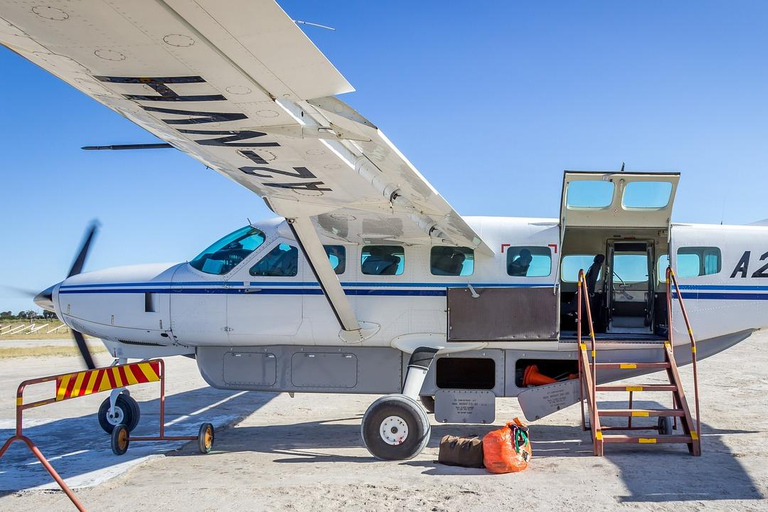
top-left (54, 217), bottom-right (768, 396)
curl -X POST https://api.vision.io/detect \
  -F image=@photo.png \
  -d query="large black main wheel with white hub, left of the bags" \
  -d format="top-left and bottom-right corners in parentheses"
top-left (361, 395), bottom-right (431, 460)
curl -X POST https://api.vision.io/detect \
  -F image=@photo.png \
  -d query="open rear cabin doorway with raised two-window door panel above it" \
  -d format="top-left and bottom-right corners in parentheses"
top-left (560, 171), bottom-right (680, 335)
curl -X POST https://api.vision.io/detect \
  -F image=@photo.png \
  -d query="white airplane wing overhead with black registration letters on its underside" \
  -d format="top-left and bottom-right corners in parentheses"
top-left (0, 0), bottom-right (492, 254)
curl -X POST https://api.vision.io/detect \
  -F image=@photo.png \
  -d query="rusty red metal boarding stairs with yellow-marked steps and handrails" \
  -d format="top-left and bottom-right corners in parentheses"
top-left (577, 267), bottom-right (701, 456)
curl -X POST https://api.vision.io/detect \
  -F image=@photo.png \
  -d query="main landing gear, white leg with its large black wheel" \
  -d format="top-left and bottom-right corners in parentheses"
top-left (360, 347), bottom-right (437, 460)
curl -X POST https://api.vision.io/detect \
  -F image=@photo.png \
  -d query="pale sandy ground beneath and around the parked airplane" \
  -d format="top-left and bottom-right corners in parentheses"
top-left (0, 333), bottom-right (768, 511)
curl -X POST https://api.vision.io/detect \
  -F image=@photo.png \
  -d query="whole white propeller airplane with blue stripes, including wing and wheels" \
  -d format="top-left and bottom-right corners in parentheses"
top-left (0, 0), bottom-right (768, 459)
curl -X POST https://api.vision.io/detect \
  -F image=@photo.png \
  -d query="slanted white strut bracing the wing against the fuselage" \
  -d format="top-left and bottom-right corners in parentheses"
top-left (286, 217), bottom-right (368, 342)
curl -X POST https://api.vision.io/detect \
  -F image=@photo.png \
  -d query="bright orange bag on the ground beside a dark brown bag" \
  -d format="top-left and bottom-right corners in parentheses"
top-left (483, 418), bottom-right (532, 473)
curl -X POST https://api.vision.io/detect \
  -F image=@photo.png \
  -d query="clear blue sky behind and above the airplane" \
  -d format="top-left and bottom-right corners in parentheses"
top-left (0, 1), bottom-right (768, 312)
